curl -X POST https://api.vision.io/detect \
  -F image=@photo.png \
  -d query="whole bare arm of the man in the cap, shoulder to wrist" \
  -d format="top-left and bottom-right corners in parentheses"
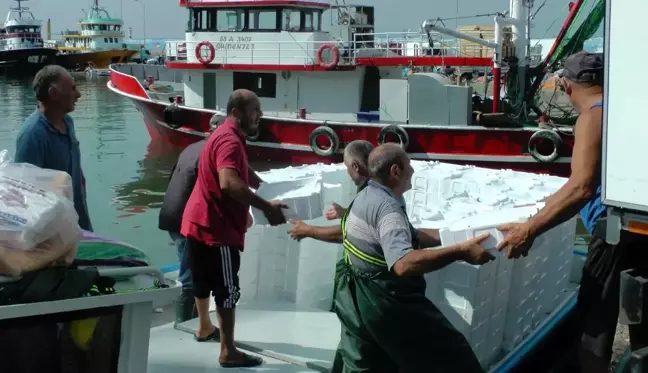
top-left (527, 108), bottom-right (602, 235)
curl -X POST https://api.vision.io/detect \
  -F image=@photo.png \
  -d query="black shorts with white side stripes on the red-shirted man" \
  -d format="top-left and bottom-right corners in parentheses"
top-left (187, 239), bottom-right (241, 308)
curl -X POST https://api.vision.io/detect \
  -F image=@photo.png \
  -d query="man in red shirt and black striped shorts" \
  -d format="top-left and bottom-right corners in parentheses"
top-left (181, 90), bottom-right (287, 368)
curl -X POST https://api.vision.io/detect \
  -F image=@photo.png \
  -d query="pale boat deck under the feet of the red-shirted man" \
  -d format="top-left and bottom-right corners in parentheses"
top-left (148, 301), bottom-right (340, 373)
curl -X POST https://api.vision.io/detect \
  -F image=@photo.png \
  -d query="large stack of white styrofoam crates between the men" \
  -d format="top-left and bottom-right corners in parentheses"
top-left (241, 162), bottom-right (574, 360)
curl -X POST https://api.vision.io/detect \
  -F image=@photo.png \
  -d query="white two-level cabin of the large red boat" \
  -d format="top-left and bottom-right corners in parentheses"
top-left (167, 0), bottom-right (492, 124)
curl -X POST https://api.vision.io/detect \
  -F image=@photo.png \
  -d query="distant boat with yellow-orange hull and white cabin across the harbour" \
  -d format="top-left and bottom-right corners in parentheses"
top-left (56, 0), bottom-right (138, 71)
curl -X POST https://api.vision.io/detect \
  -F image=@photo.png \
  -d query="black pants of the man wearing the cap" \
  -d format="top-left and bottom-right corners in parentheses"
top-left (578, 231), bottom-right (648, 360)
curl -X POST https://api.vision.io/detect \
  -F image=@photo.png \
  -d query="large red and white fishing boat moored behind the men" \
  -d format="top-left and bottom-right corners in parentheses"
top-left (108, 0), bottom-right (602, 176)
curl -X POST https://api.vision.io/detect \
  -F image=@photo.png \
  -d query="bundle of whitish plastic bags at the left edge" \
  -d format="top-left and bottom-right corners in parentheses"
top-left (0, 150), bottom-right (82, 275)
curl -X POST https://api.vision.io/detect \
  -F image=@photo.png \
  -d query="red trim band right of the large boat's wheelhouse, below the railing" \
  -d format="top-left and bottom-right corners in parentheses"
top-left (356, 56), bottom-right (493, 66)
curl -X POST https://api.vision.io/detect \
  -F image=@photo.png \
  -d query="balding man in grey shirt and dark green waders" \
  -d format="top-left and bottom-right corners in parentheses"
top-left (335, 144), bottom-right (494, 373)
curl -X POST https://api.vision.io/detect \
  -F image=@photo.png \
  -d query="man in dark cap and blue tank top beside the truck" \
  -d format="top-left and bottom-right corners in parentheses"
top-left (498, 52), bottom-right (648, 373)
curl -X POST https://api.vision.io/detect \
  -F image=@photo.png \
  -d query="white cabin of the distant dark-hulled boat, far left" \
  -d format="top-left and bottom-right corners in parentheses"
top-left (0, 0), bottom-right (43, 52)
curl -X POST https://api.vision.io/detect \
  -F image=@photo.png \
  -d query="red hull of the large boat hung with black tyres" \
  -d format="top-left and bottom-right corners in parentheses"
top-left (107, 64), bottom-right (573, 176)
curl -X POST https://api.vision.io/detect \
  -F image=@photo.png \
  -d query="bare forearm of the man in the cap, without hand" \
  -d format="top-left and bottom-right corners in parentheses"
top-left (527, 182), bottom-right (593, 236)
